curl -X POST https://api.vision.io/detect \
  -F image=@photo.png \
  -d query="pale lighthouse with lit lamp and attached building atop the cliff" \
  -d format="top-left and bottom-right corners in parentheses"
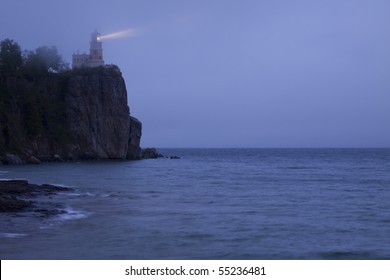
top-left (72, 31), bottom-right (104, 69)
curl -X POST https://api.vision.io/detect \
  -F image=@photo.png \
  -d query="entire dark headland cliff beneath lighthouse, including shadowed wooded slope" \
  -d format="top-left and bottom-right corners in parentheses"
top-left (0, 66), bottom-right (142, 162)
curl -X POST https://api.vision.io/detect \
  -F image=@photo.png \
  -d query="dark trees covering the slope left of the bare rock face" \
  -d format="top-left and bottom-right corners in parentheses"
top-left (0, 39), bottom-right (70, 153)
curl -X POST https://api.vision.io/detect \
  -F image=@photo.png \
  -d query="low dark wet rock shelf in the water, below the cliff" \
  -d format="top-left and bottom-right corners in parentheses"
top-left (0, 180), bottom-right (73, 216)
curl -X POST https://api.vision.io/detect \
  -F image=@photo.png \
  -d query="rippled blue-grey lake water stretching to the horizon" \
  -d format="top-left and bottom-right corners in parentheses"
top-left (0, 149), bottom-right (390, 259)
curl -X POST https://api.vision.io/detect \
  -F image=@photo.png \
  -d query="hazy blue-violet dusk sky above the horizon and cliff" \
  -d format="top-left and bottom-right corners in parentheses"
top-left (0, 0), bottom-right (390, 148)
